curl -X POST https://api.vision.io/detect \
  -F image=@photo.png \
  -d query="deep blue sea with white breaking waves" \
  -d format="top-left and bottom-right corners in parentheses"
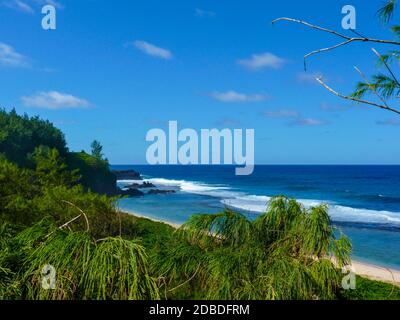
top-left (112, 165), bottom-right (400, 269)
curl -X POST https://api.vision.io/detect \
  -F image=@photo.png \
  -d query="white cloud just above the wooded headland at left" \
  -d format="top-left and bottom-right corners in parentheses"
top-left (21, 91), bottom-right (91, 110)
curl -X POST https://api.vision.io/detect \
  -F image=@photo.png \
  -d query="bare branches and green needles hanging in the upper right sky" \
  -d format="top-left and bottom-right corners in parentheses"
top-left (272, 0), bottom-right (400, 114)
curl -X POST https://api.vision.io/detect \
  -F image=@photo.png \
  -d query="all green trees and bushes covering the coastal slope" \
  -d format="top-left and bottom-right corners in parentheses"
top-left (0, 111), bottom-right (399, 299)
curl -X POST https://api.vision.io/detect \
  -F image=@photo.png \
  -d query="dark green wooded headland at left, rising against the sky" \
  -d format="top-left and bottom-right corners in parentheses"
top-left (0, 109), bottom-right (116, 195)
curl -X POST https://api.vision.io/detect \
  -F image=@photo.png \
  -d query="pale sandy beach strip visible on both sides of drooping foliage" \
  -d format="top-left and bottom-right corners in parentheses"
top-left (121, 210), bottom-right (400, 287)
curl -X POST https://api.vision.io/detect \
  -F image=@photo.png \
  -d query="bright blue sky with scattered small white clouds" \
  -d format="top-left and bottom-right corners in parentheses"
top-left (0, 0), bottom-right (400, 164)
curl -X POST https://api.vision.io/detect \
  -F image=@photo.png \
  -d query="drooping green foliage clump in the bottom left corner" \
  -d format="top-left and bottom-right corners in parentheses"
top-left (0, 219), bottom-right (159, 300)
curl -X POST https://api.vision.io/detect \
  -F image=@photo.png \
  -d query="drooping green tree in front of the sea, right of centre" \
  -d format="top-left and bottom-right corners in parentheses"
top-left (158, 197), bottom-right (351, 299)
